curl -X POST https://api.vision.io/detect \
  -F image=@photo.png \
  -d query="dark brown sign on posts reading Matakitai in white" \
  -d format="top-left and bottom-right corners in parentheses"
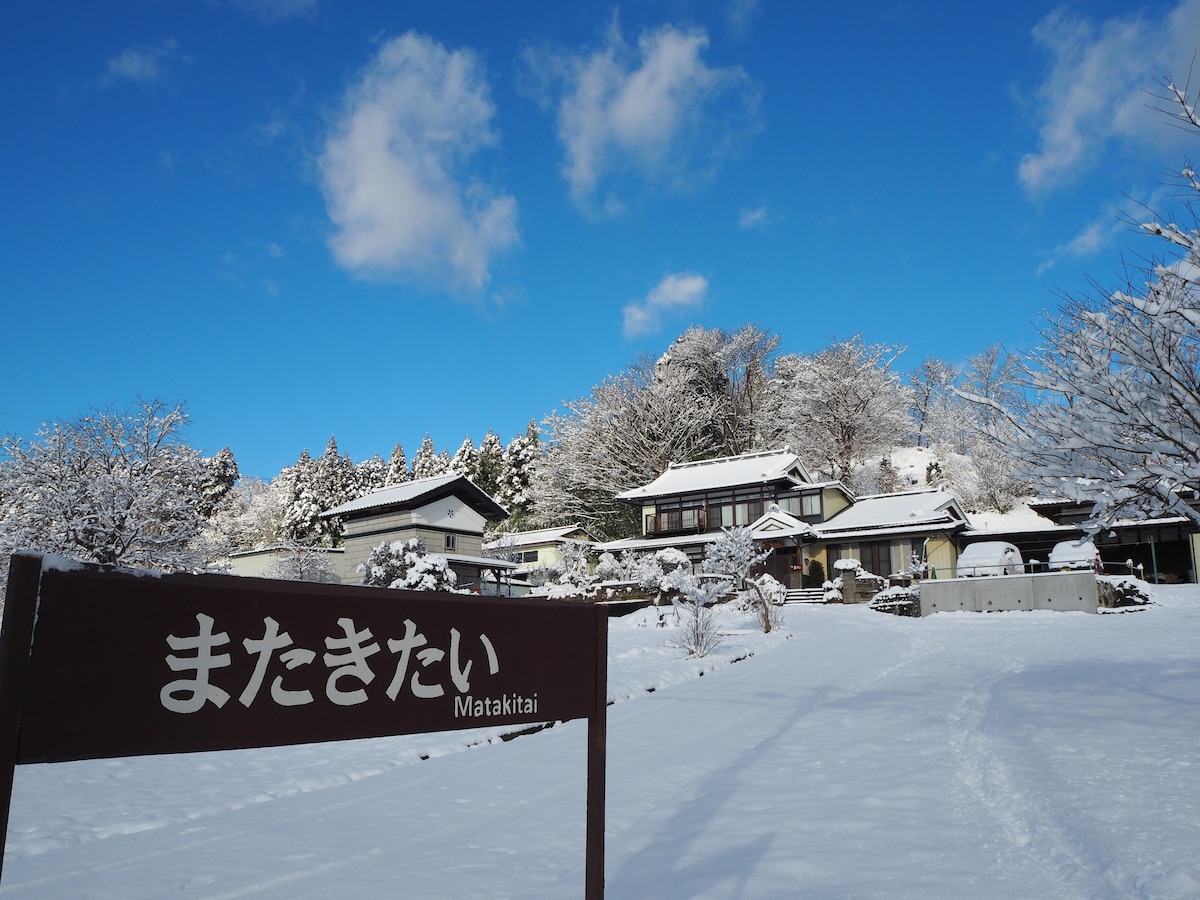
top-left (0, 554), bottom-right (607, 896)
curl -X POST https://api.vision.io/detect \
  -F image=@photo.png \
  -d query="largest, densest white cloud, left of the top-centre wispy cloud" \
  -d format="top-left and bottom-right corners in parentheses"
top-left (320, 32), bottom-right (518, 290)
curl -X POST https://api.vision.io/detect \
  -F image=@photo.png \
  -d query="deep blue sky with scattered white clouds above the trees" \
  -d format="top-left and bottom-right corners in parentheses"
top-left (7, 0), bottom-right (1200, 478)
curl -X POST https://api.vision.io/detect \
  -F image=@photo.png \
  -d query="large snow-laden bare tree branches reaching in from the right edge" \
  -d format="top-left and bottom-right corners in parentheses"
top-left (979, 79), bottom-right (1200, 532)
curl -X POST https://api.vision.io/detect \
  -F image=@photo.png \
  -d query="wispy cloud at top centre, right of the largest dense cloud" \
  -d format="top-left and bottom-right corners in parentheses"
top-left (524, 17), bottom-right (758, 212)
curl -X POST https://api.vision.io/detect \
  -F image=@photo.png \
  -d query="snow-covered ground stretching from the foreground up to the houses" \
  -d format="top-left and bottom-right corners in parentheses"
top-left (2, 586), bottom-right (1200, 900)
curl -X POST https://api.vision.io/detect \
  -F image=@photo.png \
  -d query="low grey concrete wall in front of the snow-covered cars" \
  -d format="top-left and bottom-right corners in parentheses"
top-left (920, 571), bottom-right (1097, 616)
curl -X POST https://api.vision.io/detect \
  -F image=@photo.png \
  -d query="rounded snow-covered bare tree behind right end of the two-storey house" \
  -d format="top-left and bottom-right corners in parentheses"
top-left (772, 335), bottom-right (912, 481)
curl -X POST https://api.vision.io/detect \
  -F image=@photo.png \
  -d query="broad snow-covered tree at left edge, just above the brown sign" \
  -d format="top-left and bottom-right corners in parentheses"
top-left (0, 400), bottom-right (209, 571)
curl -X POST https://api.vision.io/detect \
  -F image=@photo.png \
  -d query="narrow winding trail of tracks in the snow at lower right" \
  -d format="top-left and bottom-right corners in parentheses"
top-left (948, 660), bottom-right (1147, 899)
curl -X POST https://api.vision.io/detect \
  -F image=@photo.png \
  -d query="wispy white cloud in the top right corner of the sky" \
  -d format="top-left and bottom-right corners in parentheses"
top-left (1018, 0), bottom-right (1200, 193)
